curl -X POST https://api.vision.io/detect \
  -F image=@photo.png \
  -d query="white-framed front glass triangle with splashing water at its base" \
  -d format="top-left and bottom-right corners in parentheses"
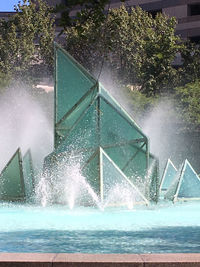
top-left (101, 150), bottom-right (148, 206)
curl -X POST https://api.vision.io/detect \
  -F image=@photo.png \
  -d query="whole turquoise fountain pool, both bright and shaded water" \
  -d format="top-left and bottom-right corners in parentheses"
top-left (0, 202), bottom-right (200, 253)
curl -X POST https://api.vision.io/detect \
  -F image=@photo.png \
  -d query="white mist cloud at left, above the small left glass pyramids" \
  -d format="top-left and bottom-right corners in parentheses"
top-left (0, 86), bottom-right (53, 171)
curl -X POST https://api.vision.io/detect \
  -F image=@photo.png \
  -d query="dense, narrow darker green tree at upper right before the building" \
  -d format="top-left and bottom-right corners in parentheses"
top-left (139, 14), bottom-right (182, 95)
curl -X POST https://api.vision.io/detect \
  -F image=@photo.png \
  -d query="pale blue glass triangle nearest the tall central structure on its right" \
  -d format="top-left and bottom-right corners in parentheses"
top-left (160, 159), bottom-right (177, 198)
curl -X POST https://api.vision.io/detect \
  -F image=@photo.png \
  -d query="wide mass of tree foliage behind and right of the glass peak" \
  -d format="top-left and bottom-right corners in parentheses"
top-left (65, 6), bottom-right (181, 96)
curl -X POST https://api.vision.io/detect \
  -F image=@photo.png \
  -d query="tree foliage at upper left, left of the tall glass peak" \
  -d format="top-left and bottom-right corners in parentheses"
top-left (0, 0), bottom-right (54, 82)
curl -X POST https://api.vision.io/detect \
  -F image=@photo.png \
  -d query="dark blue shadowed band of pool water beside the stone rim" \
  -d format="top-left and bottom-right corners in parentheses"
top-left (0, 227), bottom-right (200, 254)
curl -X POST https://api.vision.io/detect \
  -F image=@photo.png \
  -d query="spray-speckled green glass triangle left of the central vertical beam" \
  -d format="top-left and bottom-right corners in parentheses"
top-left (55, 101), bottom-right (99, 153)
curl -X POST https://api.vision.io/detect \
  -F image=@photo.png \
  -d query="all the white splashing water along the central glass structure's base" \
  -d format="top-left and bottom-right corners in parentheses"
top-left (35, 156), bottom-right (147, 210)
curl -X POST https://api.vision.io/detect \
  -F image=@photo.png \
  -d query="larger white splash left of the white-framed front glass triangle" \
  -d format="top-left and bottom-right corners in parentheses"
top-left (35, 157), bottom-right (101, 209)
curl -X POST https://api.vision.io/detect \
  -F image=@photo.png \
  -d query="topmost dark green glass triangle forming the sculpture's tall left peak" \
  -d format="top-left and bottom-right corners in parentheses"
top-left (55, 45), bottom-right (96, 122)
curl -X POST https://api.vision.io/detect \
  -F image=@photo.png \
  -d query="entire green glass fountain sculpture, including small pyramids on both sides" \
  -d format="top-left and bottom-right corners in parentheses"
top-left (0, 44), bottom-right (200, 206)
